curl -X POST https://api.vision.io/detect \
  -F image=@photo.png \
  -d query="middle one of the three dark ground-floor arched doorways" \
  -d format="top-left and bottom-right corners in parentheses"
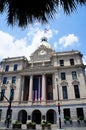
top-left (32, 110), bottom-right (41, 124)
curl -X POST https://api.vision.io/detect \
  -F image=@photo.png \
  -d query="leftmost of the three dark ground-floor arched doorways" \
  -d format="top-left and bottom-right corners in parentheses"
top-left (18, 110), bottom-right (27, 124)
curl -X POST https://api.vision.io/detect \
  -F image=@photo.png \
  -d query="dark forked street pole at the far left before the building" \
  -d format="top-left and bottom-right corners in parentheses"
top-left (0, 88), bottom-right (13, 128)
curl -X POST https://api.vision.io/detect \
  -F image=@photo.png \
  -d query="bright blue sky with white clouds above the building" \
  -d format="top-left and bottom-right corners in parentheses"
top-left (0, 6), bottom-right (86, 64)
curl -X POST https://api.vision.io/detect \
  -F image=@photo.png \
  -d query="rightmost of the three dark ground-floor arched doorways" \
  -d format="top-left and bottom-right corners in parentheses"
top-left (46, 109), bottom-right (56, 124)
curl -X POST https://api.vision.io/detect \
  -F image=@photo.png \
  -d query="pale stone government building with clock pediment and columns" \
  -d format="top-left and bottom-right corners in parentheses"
top-left (0, 37), bottom-right (86, 125)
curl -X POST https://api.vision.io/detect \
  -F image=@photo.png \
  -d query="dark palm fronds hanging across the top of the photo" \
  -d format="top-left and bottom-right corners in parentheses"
top-left (0, 0), bottom-right (86, 27)
